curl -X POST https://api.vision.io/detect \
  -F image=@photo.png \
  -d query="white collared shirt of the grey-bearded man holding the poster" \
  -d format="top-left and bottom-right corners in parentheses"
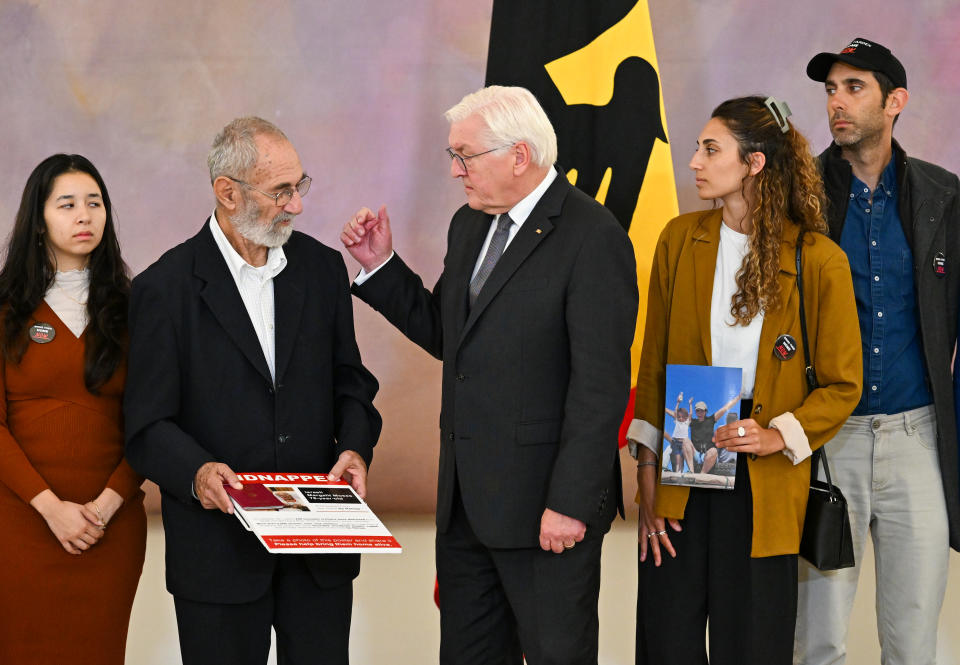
top-left (210, 212), bottom-right (287, 379)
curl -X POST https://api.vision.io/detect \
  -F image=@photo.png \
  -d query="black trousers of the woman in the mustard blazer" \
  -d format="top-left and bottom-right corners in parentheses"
top-left (636, 455), bottom-right (797, 665)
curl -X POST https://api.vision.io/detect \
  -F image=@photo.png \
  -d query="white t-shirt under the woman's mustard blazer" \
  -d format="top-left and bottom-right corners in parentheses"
top-left (710, 224), bottom-right (763, 399)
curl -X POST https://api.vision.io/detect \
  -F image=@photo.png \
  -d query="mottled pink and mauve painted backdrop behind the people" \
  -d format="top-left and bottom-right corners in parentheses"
top-left (0, 0), bottom-right (960, 512)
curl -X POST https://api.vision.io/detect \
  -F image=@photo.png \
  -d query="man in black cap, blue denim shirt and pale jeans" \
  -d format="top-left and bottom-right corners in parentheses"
top-left (795, 38), bottom-right (960, 665)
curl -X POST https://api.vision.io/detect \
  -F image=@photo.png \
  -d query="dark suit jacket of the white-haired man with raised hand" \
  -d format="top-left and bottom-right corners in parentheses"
top-left (353, 173), bottom-right (637, 547)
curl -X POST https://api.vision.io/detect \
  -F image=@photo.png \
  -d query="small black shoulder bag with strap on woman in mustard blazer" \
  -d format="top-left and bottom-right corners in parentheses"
top-left (797, 231), bottom-right (854, 570)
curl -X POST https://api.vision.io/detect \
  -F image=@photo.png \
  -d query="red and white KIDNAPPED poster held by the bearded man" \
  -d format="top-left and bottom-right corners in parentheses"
top-left (224, 472), bottom-right (402, 554)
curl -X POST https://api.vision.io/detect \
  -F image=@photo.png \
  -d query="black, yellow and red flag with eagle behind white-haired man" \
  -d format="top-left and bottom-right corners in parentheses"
top-left (487, 0), bottom-right (677, 446)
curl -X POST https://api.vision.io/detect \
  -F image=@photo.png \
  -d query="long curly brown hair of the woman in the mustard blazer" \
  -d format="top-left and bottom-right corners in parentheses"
top-left (710, 97), bottom-right (827, 325)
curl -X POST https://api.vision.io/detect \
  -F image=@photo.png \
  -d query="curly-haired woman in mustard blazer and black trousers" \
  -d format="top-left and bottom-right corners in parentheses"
top-left (629, 97), bottom-right (861, 665)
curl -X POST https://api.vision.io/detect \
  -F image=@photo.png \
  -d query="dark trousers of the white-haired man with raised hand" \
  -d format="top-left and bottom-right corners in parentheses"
top-left (437, 480), bottom-right (604, 665)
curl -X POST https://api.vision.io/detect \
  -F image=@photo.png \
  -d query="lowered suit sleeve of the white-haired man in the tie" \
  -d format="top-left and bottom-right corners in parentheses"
top-left (546, 220), bottom-right (638, 524)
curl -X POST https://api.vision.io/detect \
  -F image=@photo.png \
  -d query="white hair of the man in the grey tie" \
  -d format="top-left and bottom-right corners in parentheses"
top-left (443, 85), bottom-right (557, 166)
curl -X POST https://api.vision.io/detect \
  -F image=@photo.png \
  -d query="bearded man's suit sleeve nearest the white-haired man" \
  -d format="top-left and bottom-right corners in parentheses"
top-left (333, 254), bottom-right (382, 466)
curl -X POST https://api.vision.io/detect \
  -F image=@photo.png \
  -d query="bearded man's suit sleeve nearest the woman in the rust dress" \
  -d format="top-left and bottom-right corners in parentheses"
top-left (124, 276), bottom-right (217, 503)
